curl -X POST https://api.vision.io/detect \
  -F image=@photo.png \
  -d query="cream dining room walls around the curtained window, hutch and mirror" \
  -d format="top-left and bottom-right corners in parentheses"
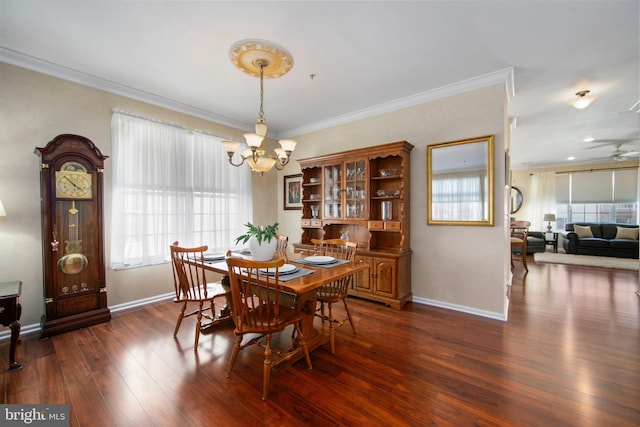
top-left (0, 63), bottom-right (508, 328)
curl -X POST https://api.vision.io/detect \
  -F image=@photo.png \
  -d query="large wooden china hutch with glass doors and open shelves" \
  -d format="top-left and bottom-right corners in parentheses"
top-left (294, 141), bottom-right (413, 308)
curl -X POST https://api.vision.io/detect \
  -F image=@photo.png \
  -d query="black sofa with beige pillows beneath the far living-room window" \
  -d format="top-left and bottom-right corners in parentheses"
top-left (562, 222), bottom-right (638, 259)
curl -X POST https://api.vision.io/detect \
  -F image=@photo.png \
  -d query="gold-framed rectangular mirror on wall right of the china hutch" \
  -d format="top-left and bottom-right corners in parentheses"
top-left (427, 135), bottom-right (494, 226)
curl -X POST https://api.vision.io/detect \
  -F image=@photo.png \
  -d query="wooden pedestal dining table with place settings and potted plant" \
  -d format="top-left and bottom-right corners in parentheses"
top-left (204, 253), bottom-right (369, 352)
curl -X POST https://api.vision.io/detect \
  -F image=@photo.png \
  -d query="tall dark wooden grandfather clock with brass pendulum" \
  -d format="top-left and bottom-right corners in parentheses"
top-left (35, 134), bottom-right (111, 337)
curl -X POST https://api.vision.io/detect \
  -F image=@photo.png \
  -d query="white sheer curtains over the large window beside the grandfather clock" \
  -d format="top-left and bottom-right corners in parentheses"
top-left (111, 112), bottom-right (252, 268)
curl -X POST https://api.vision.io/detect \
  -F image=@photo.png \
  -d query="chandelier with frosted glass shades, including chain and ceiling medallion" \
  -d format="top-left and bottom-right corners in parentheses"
top-left (222, 40), bottom-right (297, 174)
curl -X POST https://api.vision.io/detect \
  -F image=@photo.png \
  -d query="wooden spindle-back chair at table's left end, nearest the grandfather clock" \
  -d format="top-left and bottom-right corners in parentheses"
top-left (170, 242), bottom-right (230, 351)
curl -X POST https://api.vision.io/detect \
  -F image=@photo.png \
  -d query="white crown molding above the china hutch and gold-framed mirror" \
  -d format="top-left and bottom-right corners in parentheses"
top-left (278, 67), bottom-right (515, 138)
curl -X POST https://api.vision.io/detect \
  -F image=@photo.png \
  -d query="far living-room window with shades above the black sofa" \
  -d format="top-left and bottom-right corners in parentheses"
top-left (556, 168), bottom-right (638, 229)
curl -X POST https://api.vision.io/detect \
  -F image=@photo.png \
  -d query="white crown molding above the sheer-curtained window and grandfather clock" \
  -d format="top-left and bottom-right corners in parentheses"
top-left (0, 47), bottom-right (253, 130)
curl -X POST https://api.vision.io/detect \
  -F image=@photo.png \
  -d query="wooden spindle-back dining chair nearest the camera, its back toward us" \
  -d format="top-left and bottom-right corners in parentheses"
top-left (227, 253), bottom-right (311, 400)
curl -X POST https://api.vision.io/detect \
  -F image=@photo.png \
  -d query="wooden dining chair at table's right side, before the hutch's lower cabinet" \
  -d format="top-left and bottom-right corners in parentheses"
top-left (311, 239), bottom-right (358, 354)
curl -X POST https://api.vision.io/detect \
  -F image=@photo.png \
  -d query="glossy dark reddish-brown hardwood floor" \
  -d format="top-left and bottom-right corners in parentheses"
top-left (0, 259), bottom-right (640, 427)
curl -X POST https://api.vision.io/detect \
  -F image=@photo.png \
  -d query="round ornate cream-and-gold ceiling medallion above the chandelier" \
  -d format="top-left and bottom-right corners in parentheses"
top-left (229, 40), bottom-right (293, 78)
